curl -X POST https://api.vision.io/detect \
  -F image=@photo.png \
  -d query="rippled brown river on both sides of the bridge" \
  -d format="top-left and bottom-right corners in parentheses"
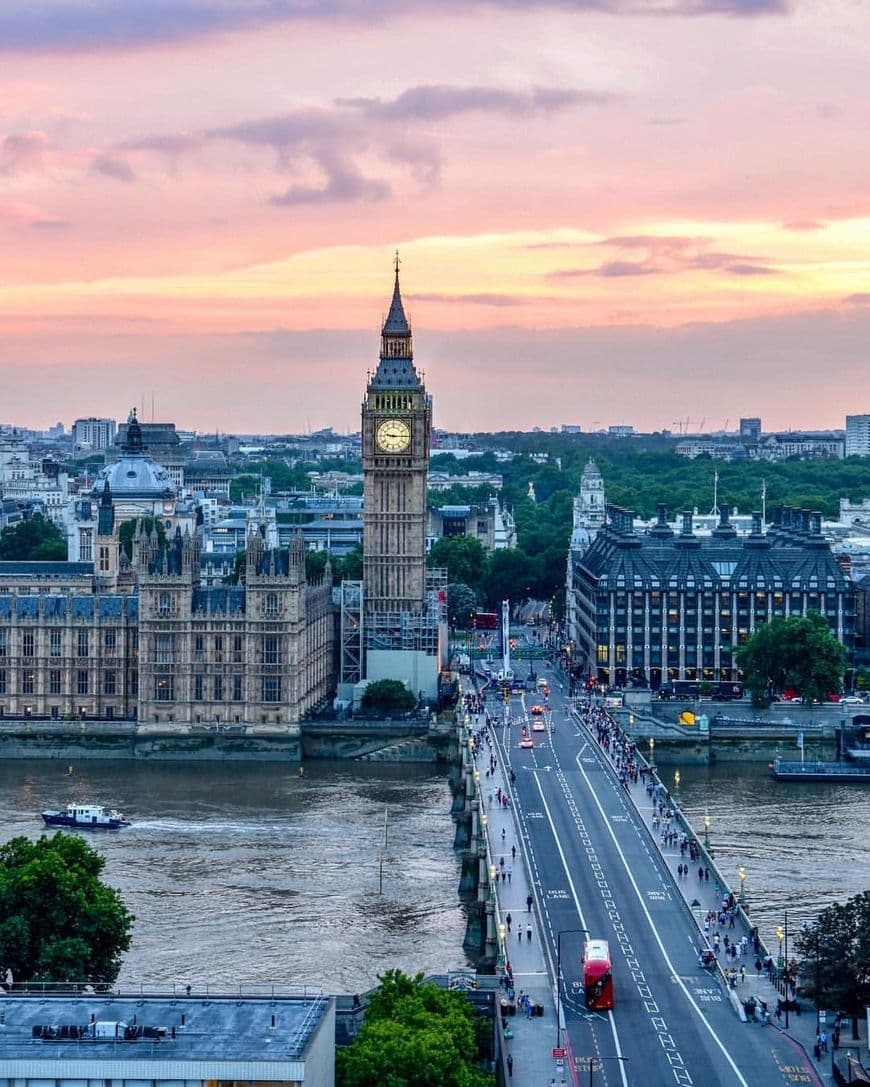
top-left (0, 760), bottom-right (870, 992)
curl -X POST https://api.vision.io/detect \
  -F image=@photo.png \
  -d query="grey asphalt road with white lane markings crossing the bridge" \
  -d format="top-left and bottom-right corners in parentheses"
top-left (482, 656), bottom-right (822, 1087)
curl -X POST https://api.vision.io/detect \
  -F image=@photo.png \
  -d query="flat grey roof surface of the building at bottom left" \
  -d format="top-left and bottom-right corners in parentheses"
top-left (0, 994), bottom-right (330, 1062)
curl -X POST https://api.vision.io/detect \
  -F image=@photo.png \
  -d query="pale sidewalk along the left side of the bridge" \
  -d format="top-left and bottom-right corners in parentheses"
top-left (472, 716), bottom-right (568, 1087)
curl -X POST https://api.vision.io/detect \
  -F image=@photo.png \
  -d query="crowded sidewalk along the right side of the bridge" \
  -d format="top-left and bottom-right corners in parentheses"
top-left (584, 700), bottom-right (839, 1085)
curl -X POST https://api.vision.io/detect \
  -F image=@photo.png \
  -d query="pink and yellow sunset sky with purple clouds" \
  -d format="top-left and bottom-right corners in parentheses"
top-left (0, 0), bottom-right (870, 433)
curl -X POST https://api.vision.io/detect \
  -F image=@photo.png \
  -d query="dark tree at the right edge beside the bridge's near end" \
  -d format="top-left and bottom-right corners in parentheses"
top-left (795, 891), bottom-right (870, 1037)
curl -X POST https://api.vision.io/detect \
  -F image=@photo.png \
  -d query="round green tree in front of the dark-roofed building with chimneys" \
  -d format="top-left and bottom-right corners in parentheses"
top-left (736, 611), bottom-right (846, 703)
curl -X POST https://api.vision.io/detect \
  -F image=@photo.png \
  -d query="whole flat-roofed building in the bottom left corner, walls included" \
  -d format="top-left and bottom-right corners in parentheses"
top-left (0, 986), bottom-right (335, 1087)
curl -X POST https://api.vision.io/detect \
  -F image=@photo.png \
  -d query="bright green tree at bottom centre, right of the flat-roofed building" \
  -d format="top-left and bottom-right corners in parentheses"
top-left (336, 970), bottom-right (495, 1087)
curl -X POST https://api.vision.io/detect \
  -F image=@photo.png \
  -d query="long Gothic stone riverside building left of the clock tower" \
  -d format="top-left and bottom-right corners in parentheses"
top-left (0, 482), bottom-right (335, 736)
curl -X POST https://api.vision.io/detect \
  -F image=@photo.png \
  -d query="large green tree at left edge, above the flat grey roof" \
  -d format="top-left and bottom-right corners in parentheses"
top-left (0, 833), bottom-right (134, 982)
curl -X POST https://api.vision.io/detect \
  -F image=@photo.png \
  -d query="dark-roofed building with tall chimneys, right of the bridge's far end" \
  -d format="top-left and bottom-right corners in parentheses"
top-left (571, 507), bottom-right (855, 689)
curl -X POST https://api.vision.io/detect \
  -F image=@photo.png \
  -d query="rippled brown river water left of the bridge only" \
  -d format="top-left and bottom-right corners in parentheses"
top-left (0, 761), bottom-right (467, 992)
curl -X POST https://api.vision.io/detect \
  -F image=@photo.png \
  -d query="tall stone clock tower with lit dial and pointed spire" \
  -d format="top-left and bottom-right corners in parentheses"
top-left (362, 254), bottom-right (432, 621)
